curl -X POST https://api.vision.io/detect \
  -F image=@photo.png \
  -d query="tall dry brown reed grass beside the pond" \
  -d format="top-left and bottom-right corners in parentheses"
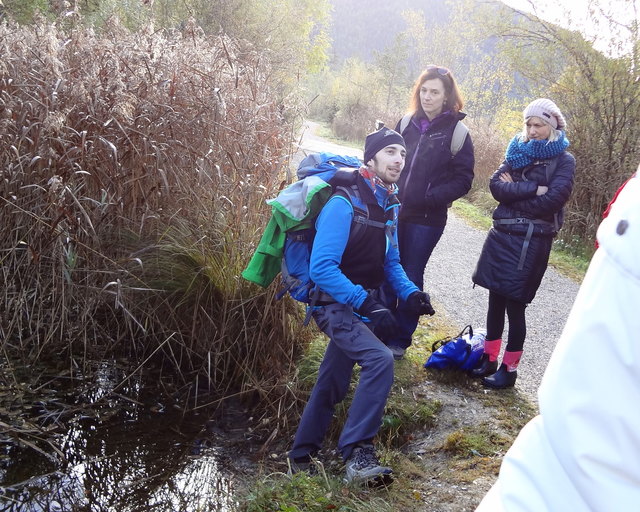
top-left (0, 20), bottom-right (305, 420)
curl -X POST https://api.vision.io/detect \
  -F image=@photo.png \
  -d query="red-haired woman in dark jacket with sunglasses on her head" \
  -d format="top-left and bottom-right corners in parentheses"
top-left (385, 66), bottom-right (474, 359)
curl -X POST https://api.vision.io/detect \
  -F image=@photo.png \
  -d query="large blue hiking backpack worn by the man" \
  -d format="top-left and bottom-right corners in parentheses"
top-left (277, 153), bottom-right (397, 325)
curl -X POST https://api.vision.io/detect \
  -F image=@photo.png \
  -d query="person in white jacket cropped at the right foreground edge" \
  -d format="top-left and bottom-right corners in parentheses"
top-left (476, 168), bottom-right (640, 512)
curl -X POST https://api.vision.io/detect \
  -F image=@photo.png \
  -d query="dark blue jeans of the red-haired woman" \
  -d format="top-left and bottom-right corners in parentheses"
top-left (384, 222), bottom-right (444, 348)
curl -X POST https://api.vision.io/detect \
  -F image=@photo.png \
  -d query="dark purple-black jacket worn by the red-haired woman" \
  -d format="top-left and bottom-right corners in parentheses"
top-left (396, 112), bottom-right (475, 226)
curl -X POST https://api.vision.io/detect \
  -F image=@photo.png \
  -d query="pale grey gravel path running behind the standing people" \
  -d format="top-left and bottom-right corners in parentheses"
top-left (293, 121), bottom-right (579, 400)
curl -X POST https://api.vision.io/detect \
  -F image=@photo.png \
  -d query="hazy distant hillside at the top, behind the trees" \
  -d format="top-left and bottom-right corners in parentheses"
top-left (330, 0), bottom-right (450, 63)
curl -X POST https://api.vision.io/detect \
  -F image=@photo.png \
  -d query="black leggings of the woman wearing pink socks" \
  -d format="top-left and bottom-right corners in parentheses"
top-left (487, 291), bottom-right (527, 352)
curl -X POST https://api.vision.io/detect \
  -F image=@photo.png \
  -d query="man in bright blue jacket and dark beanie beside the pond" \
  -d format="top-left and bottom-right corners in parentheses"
top-left (288, 127), bottom-right (434, 484)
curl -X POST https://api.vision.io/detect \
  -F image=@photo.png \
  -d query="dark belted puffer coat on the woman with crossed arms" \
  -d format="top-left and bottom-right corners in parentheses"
top-left (472, 152), bottom-right (575, 303)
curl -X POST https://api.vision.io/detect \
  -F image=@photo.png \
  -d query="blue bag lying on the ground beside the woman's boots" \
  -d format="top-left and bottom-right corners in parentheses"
top-left (424, 325), bottom-right (485, 370)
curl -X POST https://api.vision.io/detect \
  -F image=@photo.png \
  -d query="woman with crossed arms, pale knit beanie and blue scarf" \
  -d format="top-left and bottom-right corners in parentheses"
top-left (471, 98), bottom-right (576, 389)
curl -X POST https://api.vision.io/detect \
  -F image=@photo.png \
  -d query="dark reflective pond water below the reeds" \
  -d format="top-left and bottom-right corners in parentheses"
top-left (0, 364), bottom-right (248, 512)
